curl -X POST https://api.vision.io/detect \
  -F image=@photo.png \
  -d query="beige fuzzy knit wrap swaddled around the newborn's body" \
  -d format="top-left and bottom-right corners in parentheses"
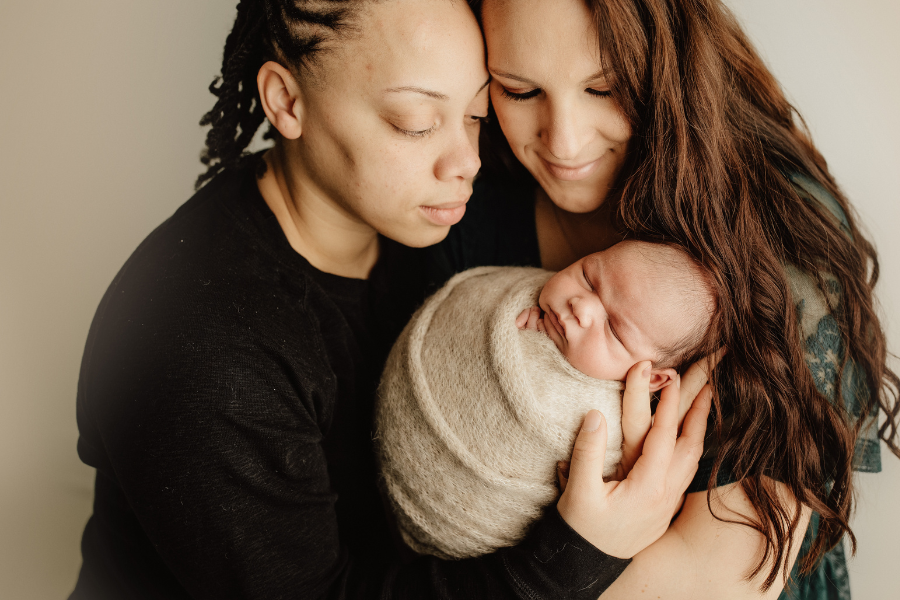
top-left (376, 267), bottom-right (623, 558)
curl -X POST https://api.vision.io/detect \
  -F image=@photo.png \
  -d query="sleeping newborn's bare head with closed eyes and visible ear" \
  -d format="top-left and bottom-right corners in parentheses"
top-left (538, 241), bottom-right (716, 391)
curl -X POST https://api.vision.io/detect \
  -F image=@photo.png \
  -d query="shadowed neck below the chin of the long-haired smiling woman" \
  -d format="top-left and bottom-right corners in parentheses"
top-left (535, 186), bottom-right (622, 271)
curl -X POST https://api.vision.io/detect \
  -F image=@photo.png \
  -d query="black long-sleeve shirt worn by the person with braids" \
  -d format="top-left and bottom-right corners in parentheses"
top-left (72, 159), bottom-right (627, 600)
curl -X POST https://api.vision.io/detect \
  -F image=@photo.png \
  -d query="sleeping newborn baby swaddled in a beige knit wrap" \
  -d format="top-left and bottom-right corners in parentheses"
top-left (375, 241), bottom-right (715, 558)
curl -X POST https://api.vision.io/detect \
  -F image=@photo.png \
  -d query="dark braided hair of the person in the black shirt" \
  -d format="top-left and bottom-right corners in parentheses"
top-left (195, 0), bottom-right (359, 188)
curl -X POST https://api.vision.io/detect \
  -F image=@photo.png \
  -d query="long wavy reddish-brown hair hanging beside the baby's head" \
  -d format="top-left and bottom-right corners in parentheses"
top-left (472, 0), bottom-right (900, 590)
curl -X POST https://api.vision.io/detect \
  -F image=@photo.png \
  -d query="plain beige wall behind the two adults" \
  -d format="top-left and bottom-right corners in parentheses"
top-left (0, 0), bottom-right (900, 600)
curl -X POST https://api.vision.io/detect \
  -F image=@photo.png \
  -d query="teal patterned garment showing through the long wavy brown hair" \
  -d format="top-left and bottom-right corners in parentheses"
top-left (779, 174), bottom-right (881, 600)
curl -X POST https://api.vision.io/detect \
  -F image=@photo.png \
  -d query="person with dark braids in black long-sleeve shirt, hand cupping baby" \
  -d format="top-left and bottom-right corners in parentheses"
top-left (72, 0), bottom-right (710, 600)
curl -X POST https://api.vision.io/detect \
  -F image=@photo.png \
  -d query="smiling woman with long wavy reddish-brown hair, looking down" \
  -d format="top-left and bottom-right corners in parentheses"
top-left (424, 0), bottom-right (900, 598)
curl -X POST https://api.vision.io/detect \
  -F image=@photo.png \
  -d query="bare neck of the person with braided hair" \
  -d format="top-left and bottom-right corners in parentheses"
top-left (257, 145), bottom-right (379, 279)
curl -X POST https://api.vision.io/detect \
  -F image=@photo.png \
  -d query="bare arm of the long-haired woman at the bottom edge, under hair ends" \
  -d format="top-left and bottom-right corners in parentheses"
top-left (601, 483), bottom-right (811, 600)
